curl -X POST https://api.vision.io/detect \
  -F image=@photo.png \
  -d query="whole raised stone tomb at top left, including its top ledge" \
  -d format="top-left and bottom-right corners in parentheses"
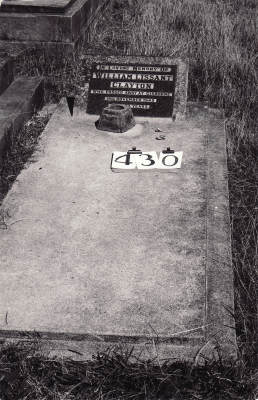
top-left (0, 0), bottom-right (109, 52)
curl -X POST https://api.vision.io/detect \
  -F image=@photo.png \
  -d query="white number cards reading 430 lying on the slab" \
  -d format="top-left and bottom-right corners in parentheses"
top-left (111, 147), bottom-right (183, 172)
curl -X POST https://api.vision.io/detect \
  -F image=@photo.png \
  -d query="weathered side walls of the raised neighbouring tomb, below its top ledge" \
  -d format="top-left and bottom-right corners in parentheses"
top-left (0, 0), bottom-right (110, 53)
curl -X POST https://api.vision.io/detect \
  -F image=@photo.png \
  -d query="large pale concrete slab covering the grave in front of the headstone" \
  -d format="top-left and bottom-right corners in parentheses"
top-left (0, 101), bottom-right (236, 358)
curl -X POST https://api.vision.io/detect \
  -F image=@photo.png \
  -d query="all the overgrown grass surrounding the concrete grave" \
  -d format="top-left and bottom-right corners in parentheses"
top-left (0, 0), bottom-right (258, 400)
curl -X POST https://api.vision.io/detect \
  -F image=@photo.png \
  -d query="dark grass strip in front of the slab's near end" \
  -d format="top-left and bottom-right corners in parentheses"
top-left (0, 342), bottom-right (256, 400)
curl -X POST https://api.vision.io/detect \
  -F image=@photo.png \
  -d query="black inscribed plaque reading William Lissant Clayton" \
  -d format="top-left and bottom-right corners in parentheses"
top-left (87, 63), bottom-right (176, 117)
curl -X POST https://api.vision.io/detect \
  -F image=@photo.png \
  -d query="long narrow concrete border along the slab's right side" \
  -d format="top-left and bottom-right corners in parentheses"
top-left (205, 108), bottom-right (236, 346)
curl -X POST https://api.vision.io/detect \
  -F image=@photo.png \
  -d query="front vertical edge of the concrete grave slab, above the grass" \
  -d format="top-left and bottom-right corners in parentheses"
top-left (0, 331), bottom-right (236, 365)
